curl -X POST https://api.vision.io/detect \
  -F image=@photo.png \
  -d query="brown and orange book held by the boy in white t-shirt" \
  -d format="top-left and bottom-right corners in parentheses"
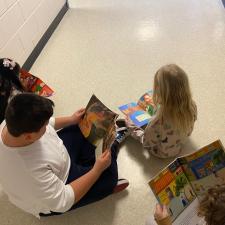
top-left (79, 95), bottom-right (118, 150)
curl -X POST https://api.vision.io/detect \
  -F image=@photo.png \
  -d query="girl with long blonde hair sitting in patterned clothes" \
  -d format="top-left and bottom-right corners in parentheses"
top-left (127, 64), bottom-right (197, 158)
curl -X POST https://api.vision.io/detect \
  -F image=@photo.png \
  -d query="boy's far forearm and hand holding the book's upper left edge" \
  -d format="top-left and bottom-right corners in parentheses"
top-left (55, 108), bottom-right (85, 130)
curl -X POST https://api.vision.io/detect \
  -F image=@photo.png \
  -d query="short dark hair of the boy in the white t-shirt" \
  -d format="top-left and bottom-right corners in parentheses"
top-left (5, 94), bottom-right (54, 137)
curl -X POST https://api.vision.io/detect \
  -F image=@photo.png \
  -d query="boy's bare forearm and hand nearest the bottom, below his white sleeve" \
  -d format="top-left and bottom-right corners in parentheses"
top-left (70, 150), bottom-right (111, 203)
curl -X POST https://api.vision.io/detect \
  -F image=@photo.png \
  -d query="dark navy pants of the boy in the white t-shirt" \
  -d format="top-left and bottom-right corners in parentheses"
top-left (41, 125), bottom-right (118, 216)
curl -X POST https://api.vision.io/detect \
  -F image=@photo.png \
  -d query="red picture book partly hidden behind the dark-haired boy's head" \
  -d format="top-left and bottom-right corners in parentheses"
top-left (19, 69), bottom-right (54, 97)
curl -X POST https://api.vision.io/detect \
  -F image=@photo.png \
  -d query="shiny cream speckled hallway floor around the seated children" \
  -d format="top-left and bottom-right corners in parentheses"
top-left (0, 0), bottom-right (225, 225)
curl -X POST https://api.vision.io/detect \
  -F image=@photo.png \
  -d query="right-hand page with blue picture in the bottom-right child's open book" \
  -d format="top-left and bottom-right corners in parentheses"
top-left (179, 141), bottom-right (225, 199)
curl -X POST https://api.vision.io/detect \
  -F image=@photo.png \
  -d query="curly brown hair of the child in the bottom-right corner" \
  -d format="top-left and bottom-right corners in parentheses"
top-left (198, 184), bottom-right (225, 225)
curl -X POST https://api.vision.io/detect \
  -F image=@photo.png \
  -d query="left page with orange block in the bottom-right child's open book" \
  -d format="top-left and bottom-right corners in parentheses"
top-left (149, 160), bottom-right (196, 221)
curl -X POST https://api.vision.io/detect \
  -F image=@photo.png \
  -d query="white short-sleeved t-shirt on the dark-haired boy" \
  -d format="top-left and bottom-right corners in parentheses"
top-left (0, 118), bottom-right (75, 217)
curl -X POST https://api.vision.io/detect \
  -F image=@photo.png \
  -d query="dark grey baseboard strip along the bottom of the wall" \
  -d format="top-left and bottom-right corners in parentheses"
top-left (22, 3), bottom-right (69, 71)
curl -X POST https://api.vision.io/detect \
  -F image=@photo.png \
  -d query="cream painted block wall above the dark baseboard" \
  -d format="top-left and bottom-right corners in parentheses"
top-left (0, 0), bottom-right (66, 65)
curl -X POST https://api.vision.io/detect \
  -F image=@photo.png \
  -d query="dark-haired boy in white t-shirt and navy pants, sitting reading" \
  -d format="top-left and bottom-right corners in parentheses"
top-left (0, 94), bottom-right (129, 217)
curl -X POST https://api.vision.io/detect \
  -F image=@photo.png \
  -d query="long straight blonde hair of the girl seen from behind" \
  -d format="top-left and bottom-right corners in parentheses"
top-left (153, 64), bottom-right (196, 135)
